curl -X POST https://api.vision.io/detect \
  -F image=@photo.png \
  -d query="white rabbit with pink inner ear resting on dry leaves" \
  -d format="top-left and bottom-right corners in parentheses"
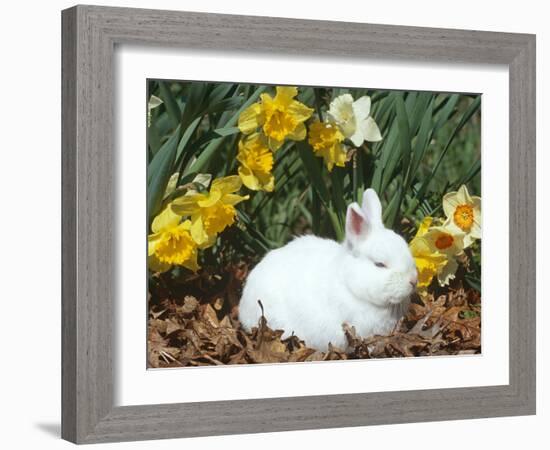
top-left (239, 189), bottom-right (417, 351)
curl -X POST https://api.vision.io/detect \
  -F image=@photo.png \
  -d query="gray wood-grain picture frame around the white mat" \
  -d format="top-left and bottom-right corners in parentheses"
top-left (62, 6), bottom-right (536, 443)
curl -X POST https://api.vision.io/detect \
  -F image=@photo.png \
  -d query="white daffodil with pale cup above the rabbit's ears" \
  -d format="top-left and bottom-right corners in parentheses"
top-left (328, 94), bottom-right (382, 147)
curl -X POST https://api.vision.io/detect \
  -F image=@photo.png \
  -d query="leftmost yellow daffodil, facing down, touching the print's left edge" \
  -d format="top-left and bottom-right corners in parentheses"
top-left (147, 205), bottom-right (199, 272)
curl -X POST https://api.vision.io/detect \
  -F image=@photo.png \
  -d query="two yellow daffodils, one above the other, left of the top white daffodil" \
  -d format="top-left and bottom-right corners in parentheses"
top-left (237, 86), bottom-right (313, 192)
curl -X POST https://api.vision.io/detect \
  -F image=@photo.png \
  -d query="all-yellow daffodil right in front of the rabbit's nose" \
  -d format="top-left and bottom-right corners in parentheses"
top-left (409, 217), bottom-right (449, 294)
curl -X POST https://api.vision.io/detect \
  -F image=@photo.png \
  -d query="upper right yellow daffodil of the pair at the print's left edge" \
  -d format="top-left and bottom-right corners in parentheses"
top-left (171, 175), bottom-right (248, 248)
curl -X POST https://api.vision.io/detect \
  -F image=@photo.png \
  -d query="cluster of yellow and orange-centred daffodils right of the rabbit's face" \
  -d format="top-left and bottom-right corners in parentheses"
top-left (409, 185), bottom-right (481, 294)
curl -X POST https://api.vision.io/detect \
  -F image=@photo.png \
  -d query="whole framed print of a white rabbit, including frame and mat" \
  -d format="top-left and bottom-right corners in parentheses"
top-left (62, 6), bottom-right (535, 443)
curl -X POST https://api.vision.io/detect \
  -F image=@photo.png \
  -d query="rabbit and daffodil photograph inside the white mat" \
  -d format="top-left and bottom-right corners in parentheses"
top-left (147, 79), bottom-right (482, 369)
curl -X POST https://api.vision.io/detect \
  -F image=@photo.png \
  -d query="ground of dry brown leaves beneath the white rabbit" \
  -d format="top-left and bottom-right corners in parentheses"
top-left (147, 264), bottom-right (481, 368)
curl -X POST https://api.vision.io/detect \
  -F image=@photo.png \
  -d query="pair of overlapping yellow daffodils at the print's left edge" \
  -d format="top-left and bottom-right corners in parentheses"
top-left (147, 175), bottom-right (248, 272)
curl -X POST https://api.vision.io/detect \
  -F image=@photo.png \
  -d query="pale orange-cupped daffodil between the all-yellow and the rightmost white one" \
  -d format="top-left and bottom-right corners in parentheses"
top-left (422, 227), bottom-right (464, 286)
